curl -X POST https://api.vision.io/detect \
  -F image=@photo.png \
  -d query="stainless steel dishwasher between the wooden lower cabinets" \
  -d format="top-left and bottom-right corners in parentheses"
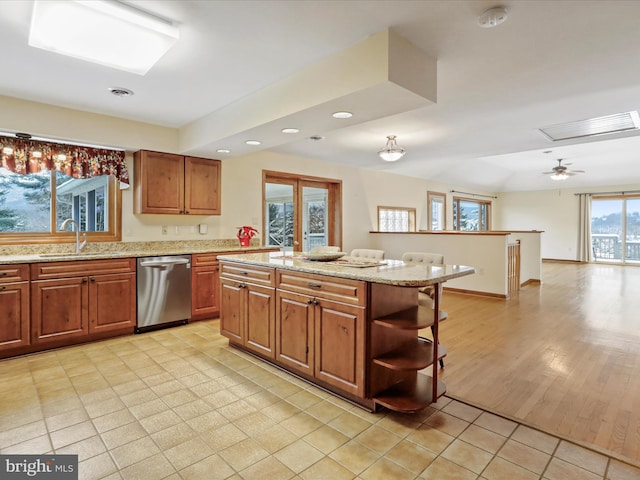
top-left (135, 255), bottom-right (191, 333)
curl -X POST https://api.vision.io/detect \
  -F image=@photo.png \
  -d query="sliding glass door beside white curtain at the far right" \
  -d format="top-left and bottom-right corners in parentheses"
top-left (591, 196), bottom-right (640, 264)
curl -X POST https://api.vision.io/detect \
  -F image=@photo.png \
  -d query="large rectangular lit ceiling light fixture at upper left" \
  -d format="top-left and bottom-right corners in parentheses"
top-left (29, 0), bottom-right (180, 75)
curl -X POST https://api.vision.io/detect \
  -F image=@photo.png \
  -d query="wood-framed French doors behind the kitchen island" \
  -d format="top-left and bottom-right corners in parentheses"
top-left (263, 172), bottom-right (342, 252)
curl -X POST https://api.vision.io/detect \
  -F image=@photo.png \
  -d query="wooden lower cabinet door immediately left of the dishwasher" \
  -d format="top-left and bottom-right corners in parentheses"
top-left (89, 273), bottom-right (136, 333)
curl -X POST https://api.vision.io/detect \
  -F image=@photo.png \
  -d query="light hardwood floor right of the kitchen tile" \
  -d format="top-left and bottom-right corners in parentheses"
top-left (428, 262), bottom-right (640, 465)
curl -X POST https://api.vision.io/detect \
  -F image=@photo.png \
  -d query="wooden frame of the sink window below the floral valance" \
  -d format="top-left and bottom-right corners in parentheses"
top-left (0, 170), bottom-right (122, 245)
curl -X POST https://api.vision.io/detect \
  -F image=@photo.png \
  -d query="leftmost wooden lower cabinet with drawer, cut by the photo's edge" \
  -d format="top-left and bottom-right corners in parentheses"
top-left (0, 265), bottom-right (30, 351)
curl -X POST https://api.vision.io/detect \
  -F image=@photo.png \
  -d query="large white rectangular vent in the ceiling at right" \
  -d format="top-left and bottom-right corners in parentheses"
top-left (540, 111), bottom-right (640, 142)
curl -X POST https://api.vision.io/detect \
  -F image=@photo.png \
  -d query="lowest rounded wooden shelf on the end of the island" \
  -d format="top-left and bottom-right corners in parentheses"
top-left (373, 375), bottom-right (447, 413)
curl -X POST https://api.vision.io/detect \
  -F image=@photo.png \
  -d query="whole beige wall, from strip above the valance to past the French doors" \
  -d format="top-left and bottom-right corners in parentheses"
top-left (0, 96), bottom-right (496, 255)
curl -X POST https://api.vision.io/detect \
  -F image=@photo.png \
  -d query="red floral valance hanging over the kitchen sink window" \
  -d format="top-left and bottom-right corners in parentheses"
top-left (0, 135), bottom-right (129, 188)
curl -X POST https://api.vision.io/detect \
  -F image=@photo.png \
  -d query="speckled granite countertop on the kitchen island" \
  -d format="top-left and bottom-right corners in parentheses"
top-left (221, 252), bottom-right (475, 287)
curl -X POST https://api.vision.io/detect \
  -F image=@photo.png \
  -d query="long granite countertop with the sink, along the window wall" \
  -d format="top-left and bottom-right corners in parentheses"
top-left (0, 240), bottom-right (273, 265)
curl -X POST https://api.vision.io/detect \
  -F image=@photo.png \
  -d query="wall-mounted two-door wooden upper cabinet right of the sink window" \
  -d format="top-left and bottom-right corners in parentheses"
top-left (133, 150), bottom-right (222, 215)
